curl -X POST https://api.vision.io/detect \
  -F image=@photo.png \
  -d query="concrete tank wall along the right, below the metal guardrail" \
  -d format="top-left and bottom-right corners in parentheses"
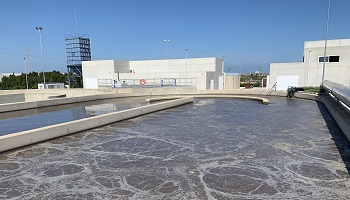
top-left (294, 93), bottom-right (350, 142)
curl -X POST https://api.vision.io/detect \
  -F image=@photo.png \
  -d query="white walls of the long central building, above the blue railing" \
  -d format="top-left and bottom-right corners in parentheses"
top-left (83, 58), bottom-right (223, 90)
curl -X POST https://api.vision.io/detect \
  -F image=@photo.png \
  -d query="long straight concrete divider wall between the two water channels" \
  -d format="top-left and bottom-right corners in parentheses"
top-left (0, 97), bottom-right (193, 152)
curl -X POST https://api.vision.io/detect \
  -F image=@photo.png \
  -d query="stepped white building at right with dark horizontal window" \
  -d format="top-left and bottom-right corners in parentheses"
top-left (268, 39), bottom-right (350, 90)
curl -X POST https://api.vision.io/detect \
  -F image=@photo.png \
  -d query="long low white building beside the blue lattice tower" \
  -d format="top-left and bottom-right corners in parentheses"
top-left (82, 57), bottom-right (224, 90)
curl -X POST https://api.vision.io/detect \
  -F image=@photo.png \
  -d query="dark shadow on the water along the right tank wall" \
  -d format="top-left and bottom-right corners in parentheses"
top-left (317, 102), bottom-right (350, 174)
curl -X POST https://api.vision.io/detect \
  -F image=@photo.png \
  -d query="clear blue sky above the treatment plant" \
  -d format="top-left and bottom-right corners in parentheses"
top-left (0, 0), bottom-right (350, 73)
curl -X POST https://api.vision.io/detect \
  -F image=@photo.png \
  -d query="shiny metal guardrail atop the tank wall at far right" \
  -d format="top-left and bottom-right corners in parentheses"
top-left (321, 81), bottom-right (350, 110)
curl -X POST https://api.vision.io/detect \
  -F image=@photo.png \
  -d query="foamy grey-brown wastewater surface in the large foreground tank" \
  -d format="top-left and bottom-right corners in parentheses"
top-left (0, 98), bottom-right (350, 199)
